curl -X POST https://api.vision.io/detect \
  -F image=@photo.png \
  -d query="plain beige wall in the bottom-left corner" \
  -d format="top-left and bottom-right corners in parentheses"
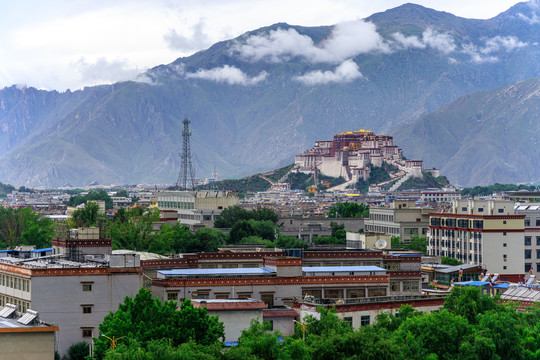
top-left (0, 331), bottom-right (54, 360)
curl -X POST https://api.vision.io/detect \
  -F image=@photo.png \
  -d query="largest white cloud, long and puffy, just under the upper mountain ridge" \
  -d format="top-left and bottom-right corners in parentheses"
top-left (231, 20), bottom-right (390, 63)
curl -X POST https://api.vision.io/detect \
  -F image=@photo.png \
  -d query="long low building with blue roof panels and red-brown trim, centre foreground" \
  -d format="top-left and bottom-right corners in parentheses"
top-left (152, 257), bottom-right (390, 306)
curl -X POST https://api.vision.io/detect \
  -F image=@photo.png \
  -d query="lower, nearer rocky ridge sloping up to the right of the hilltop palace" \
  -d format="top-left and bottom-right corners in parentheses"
top-left (394, 79), bottom-right (540, 186)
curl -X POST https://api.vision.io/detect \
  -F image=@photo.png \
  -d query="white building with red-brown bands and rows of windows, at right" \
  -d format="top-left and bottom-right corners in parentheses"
top-left (427, 200), bottom-right (526, 282)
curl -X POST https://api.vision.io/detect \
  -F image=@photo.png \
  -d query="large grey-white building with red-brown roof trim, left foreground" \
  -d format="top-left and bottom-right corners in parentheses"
top-left (0, 228), bottom-right (142, 354)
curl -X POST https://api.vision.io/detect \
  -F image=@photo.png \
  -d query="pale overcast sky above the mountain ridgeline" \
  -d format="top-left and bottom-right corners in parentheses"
top-left (0, 0), bottom-right (518, 91)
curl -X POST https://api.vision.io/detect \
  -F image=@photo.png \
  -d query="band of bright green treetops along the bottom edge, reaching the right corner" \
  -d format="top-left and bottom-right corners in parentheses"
top-left (100, 287), bottom-right (540, 360)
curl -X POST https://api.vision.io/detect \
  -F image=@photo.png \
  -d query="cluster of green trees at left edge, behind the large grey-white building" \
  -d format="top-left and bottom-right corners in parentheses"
top-left (0, 207), bottom-right (54, 249)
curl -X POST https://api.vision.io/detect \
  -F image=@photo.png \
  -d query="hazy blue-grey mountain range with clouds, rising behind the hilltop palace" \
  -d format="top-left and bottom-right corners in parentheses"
top-left (0, 1), bottom-right (540, 186)
